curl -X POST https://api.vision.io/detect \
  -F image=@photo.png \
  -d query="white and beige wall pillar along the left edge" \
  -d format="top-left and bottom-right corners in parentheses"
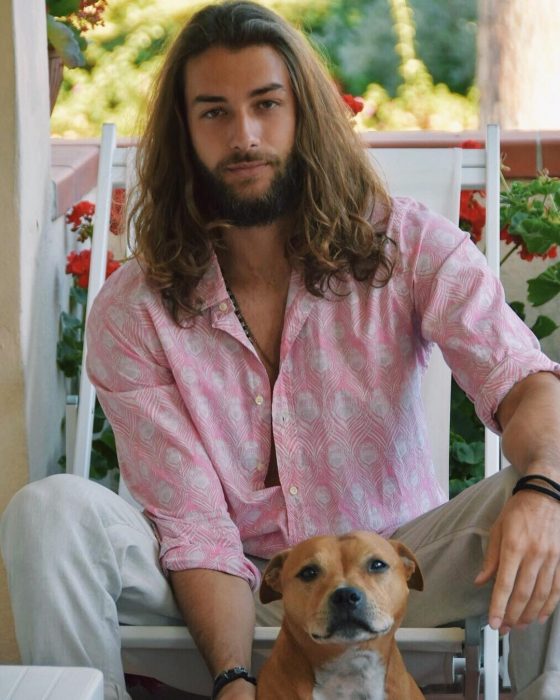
top-left (0, 0), bottom-right (64, 663)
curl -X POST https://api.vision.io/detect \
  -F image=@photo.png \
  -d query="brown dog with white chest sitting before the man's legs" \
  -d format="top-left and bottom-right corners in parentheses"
top-left (257, 532), bottom-right (423, 700)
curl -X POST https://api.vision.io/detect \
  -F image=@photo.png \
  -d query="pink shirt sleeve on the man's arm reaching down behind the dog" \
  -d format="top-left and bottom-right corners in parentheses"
top-left (87, 273), bottom-right (259, 589)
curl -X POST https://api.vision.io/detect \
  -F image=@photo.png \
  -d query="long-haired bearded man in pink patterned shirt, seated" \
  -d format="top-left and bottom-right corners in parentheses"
top-left (2, 2), bottom-right (560, 700)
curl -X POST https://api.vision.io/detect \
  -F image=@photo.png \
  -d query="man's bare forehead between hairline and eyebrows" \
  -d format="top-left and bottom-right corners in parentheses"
top-left (185, 45), bottom-right (291, 105)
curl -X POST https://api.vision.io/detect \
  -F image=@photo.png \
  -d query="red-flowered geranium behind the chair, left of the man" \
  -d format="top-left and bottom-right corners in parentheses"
top-left (56, 188), bottom-right (124, 479)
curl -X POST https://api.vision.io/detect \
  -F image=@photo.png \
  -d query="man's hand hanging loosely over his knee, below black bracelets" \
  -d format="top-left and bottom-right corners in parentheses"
top-left (475, 491), bottom-right (560, 634)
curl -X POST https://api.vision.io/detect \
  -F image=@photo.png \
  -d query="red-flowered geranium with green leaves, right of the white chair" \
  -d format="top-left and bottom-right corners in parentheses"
top-left (449, 142), bottom-right (560, 496)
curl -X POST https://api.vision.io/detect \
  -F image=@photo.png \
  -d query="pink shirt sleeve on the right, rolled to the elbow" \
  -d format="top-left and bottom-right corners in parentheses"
top-left (398, 197), bottom-right (560, 433)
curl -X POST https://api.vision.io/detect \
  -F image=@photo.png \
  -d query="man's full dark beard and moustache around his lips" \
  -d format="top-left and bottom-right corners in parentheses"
top-left (193, 150), bottom-right (303, 228)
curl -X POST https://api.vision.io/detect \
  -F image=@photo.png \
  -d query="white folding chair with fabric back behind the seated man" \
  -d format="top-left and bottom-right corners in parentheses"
top-left (66, 125), bottom-right (500, 700)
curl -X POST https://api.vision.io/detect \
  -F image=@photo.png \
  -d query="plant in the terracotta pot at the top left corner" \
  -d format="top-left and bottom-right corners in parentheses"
top-left (46, 0), bottom-right (107, 68)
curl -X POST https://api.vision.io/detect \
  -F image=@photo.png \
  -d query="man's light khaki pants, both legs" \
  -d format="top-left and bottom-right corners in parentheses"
top-left (0, 469), bottom-right (560, 700)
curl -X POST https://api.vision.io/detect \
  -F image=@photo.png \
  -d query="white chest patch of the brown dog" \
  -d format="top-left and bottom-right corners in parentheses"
top-left (313, 649), bottom-right (385, 700)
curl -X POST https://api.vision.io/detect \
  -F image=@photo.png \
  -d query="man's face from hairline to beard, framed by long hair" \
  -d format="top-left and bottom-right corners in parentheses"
top-left (185, 46), bottom-right (301, 226)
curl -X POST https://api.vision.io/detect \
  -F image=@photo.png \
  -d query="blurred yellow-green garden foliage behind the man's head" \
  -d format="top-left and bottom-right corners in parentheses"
top-left (51, 0), bottom-right (477, 138)
